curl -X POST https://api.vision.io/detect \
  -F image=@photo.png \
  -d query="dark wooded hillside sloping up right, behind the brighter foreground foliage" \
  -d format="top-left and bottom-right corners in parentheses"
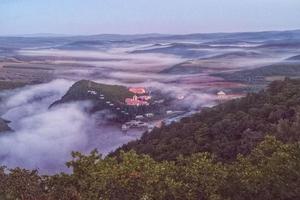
top-left (113, 79), bottom-right (300, 161)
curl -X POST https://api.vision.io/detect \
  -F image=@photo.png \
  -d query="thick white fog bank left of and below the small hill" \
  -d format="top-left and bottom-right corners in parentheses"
top-left (0, 80), bottom-right (141, 173)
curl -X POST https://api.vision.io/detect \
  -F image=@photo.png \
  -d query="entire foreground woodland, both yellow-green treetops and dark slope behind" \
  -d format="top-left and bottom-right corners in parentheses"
top-left (0, 79), bottom-right (300, 200)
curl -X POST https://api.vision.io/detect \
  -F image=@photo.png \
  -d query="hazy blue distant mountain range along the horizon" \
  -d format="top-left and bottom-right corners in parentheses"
top-left (0, 30), bottom-right (300, 50)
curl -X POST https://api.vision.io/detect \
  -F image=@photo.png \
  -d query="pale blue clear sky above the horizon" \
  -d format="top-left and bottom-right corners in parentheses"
top-left (0, 0), bottom-right (300, 35)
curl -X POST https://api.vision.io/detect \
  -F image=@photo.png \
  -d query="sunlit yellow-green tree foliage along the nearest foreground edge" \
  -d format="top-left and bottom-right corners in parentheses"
top-left (0, 136), bottom-right (300, 200)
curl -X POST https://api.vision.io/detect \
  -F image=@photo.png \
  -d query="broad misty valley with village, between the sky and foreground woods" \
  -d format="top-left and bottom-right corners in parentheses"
top-left (0, 30), bottom-right (300, 173)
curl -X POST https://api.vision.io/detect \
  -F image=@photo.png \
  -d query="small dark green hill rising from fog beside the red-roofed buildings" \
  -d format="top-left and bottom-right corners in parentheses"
top-left (50, 80), bottom-right (158, 122)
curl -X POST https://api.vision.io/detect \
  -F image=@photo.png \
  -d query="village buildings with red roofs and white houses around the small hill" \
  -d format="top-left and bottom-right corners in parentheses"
top-left (87, 83), bottom-right (234, 134)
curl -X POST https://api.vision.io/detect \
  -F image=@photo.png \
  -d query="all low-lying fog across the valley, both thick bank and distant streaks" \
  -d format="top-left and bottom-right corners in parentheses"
top-left (0, 30), bottom-right (300, 173)
